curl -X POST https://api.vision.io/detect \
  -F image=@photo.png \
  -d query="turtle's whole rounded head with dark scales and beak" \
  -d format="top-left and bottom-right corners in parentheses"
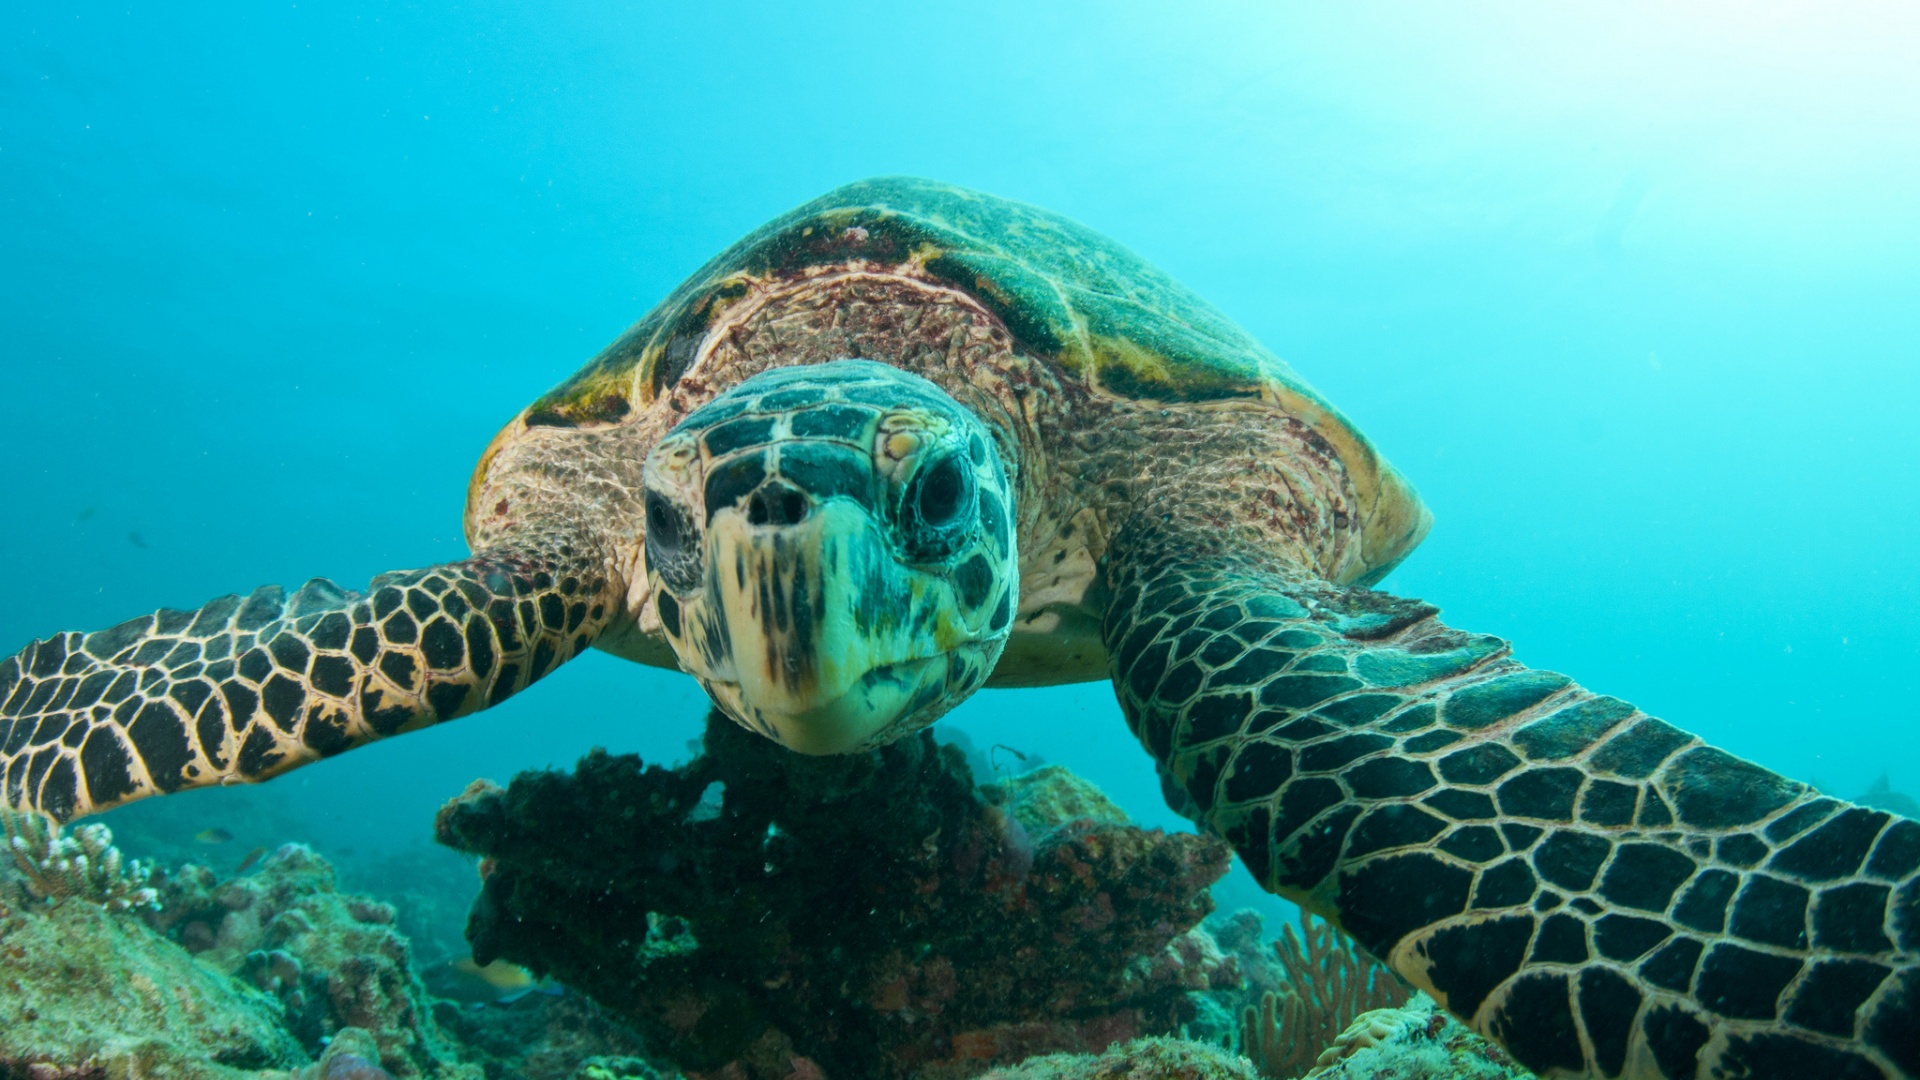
top-left (645, 359), bottom-right (1018, 753)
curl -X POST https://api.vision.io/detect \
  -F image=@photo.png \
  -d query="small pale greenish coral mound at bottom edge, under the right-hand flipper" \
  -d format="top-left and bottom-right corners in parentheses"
top-left (1306, 994), bottom-right (1534, 1080)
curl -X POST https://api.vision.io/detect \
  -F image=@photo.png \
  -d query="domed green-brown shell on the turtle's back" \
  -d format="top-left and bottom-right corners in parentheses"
top-left (522, 177), bottom-right (1430, 580)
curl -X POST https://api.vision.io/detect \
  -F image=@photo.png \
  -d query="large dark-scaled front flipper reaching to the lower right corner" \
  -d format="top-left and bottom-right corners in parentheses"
top-left (1104, 552), bottom-right (1920, 1080)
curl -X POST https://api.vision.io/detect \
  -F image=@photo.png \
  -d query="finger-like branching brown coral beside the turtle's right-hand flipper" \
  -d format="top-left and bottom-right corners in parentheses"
top-left (1240, 911), bottom-right (1413, 1080)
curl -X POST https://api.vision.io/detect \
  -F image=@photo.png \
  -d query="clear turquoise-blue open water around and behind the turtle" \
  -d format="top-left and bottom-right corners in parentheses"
top-left (0, 0), bottom-right (1920, 914)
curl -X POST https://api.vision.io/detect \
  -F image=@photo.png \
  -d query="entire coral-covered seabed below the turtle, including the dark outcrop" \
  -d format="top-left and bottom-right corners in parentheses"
top-left (0, 707), bottom-right (1528, 1080)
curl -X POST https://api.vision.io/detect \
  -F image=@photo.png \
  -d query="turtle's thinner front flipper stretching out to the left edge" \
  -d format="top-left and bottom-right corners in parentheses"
top-left (0, 548), bottom-right (618, 821)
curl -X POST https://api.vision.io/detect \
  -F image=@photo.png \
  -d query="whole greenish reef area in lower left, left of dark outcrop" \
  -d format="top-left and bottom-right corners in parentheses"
top-left (0, 795), bottom-right (691, 1080)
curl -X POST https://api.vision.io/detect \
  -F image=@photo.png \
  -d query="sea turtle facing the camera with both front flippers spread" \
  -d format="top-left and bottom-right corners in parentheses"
top-left (0, 179), bottom-right (1920, 1080)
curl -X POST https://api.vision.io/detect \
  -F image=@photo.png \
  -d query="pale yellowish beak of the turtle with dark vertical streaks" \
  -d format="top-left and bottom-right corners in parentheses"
top-left (682, 495), bottom-right (1004, 753)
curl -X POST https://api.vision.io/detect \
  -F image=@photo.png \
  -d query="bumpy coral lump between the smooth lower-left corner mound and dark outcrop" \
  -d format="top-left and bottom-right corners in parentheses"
top-left (157, 844), bottom-right (478, 1078)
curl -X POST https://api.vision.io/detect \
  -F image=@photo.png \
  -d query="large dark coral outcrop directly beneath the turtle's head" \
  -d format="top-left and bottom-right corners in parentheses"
top-left (436, 715), bottom-right (1238, 1080)
